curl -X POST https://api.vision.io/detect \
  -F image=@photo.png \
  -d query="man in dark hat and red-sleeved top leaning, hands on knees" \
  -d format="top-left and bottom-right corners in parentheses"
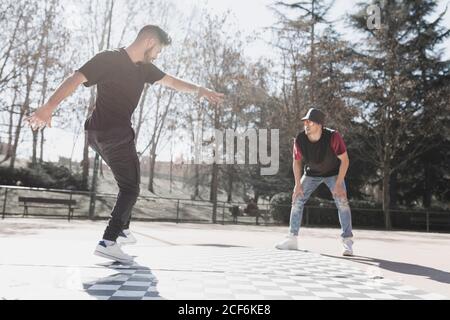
top-left (276, 108), bottom-right (353, 256)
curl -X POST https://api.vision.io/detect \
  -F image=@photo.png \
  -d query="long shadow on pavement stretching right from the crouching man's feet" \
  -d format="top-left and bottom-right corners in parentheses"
top-left (322, 254), bottom-right (450, 284)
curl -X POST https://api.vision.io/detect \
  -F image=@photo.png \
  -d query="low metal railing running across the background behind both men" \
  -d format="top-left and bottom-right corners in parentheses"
top-left (0, 185), bottom-right (450, 232)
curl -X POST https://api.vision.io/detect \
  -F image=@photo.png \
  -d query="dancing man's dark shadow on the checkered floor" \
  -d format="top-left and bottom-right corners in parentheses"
top-left (83, 262), bottom-right (163, 300)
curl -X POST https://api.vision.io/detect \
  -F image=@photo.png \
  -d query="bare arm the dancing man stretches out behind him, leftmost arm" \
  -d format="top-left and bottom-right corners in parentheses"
top-left (25, 71), bottom-right (87, 130)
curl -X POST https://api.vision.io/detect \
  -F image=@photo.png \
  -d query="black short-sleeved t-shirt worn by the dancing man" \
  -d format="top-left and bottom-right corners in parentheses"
top-left (78, 48), bottom-right (166, 131)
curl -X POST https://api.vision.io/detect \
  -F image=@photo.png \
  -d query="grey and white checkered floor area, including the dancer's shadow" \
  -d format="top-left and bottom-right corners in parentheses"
top-left (83, 246), bottom-right (446, 300)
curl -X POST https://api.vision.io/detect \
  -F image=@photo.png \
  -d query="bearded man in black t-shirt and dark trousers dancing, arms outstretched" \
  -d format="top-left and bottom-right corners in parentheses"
top-left (26, 25), bottom-right (223, 263)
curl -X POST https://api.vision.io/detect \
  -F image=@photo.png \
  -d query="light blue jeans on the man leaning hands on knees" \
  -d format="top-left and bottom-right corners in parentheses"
top-left (290, 176), bottom-right (353, 238)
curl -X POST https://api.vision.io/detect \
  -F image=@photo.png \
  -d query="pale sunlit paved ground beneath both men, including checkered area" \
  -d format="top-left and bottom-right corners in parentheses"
top-left (0, 219), bottom-right (450, 300)
